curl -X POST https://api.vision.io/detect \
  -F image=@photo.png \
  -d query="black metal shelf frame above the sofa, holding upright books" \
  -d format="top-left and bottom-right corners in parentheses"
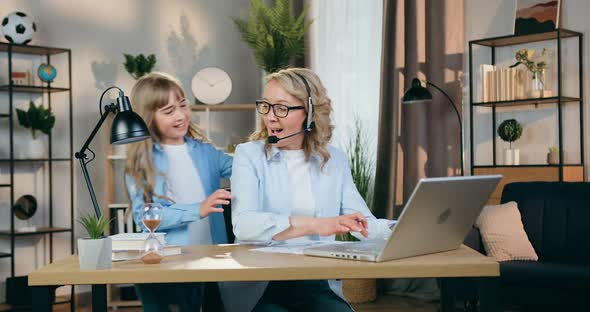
top-left (469, 28), bottom-right (586, 181)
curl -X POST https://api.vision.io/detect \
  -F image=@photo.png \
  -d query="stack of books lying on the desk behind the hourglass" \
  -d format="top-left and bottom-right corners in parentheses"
top-left (109, 233), bottom-right (182, 261)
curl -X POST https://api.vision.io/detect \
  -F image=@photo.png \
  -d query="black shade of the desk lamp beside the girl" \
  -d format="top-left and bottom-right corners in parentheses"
top-left (111, 109), bottom-right (151, 144)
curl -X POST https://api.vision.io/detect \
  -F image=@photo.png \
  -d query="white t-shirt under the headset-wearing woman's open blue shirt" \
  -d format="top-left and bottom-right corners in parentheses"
top-left (281, 150), bottom-right (315, 242)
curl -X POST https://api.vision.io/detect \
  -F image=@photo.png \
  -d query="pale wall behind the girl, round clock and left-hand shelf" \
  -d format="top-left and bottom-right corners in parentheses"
top-left (0, 0), bottom-right (260, 298)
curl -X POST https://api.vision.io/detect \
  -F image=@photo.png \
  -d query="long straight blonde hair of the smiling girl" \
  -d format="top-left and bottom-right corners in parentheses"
top-left (125, 72), bottom-right (208, 202)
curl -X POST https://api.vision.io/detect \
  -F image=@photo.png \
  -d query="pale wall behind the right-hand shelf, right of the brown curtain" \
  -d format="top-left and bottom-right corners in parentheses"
top-left (463, 0), bottom-right (590, 176)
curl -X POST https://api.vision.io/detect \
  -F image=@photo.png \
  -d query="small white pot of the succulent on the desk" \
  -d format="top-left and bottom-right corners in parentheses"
top-left (78, 237), bottom-right (113, 270)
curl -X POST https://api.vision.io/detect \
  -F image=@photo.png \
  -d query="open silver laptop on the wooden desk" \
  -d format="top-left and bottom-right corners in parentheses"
top-left (303, 175), bottom-right (502, 262)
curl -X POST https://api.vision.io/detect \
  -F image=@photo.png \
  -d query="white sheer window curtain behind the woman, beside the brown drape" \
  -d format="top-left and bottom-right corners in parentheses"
top-left (310, 0), bottom-right (383, 161)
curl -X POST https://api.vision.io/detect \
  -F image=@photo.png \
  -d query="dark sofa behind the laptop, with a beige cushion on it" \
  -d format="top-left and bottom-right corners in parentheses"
top-left (443, 182), bottom-right (590, 311)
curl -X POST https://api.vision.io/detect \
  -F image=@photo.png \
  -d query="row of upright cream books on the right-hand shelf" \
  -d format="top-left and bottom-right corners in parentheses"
top-left (480, 64), bottom-right (527, 102)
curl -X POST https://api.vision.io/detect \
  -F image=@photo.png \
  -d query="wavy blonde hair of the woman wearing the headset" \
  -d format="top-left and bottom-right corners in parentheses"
top-left (250, 68), bottom-right (334, 168)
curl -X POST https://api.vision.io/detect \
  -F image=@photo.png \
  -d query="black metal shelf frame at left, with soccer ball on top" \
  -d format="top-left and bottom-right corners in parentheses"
top-left (0, 43), bottom-right (75, 311)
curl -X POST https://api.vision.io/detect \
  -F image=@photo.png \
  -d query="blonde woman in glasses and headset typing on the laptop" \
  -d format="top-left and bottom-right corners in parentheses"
top-left (231, 68), bottom-right (390, 312)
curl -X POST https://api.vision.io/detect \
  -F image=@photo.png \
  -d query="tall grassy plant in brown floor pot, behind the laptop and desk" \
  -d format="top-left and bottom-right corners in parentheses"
top-left (336, 118), bottom-right (377, 303)
